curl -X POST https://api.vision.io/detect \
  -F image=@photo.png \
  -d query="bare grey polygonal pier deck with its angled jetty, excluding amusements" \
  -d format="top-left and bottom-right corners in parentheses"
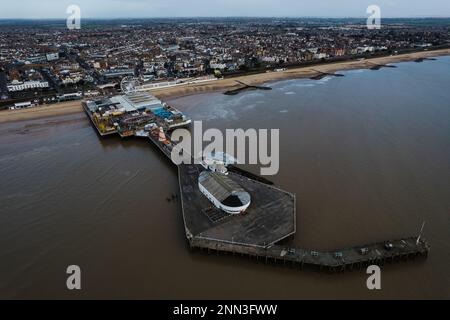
top-left (144, 130), bottom-right (430, 272)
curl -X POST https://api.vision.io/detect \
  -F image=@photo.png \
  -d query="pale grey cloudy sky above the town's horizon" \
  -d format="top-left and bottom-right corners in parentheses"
top-left (0, 0), bottom-right (450, 19)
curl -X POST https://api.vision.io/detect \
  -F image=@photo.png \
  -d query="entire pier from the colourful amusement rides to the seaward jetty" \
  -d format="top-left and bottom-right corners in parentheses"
top-left (84, 92), bottom-right (430, 272)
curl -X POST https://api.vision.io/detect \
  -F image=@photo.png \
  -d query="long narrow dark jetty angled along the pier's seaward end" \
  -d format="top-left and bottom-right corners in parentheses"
top-left (189, 238), bottom-right (430, 272)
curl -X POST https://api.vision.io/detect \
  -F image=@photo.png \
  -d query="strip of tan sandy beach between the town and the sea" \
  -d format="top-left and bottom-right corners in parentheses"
top-left (0, 49), bottom-right (450, 124)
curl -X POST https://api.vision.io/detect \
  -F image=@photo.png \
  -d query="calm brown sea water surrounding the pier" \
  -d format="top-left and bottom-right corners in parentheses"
top-left (0, 57), bottom-right (450, 299)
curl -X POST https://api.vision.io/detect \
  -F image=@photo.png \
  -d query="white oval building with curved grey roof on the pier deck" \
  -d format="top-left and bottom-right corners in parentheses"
top-left (198, 171), bottom-right (251, 214)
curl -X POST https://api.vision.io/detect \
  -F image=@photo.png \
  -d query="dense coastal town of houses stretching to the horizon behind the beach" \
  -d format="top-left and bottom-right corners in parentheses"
top-left (0, 18), bottom-right (450, 109)
